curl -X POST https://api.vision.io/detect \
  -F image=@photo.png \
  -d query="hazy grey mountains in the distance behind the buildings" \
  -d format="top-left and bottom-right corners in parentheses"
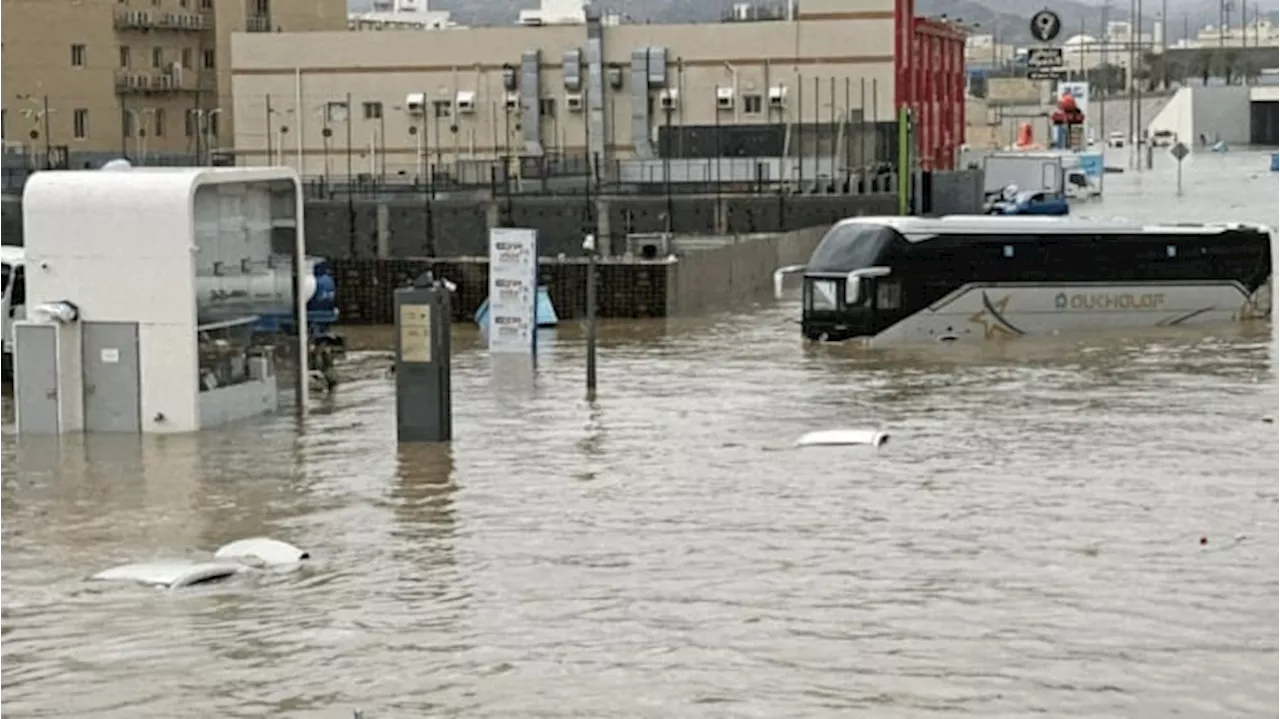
top-left (349, 0), bottom-right (1280, 45)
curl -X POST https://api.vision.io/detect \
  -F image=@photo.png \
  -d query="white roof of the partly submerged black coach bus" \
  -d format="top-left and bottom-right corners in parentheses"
top-left (841, 215), bottom-right (1271, 242)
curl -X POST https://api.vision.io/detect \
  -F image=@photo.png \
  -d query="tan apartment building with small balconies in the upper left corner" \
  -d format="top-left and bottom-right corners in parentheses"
top-left (0, 0), bottom-right (347, 157)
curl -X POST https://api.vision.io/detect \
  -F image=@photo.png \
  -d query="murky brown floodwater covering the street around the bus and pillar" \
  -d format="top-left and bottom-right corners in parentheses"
top-left (0, 149), bottom-right (1280, 719)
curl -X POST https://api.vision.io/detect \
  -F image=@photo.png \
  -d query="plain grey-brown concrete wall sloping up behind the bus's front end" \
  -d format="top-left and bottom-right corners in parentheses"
top-left (667, 225), bottom-right (828, 316)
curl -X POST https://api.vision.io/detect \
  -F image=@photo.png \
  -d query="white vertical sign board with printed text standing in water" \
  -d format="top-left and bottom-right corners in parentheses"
top-left (488, 228), bottom-right (538, 354)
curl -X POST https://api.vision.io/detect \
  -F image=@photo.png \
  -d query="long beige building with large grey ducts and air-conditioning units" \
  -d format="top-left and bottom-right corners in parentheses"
top-left (232, 0), bottom-right (893, 177)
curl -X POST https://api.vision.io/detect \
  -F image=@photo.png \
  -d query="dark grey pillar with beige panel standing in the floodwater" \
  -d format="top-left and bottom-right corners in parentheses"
top-left (396, 271), bottom-right (453, 441)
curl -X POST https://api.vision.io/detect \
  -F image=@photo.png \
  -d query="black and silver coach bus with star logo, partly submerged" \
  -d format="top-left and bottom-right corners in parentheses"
top-left (780, 216), bottom-right (1280, 344)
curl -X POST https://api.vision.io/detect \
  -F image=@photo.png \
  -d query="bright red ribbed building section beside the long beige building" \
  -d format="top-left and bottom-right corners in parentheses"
top-left (893, 0), bottom-right (965, 170)
